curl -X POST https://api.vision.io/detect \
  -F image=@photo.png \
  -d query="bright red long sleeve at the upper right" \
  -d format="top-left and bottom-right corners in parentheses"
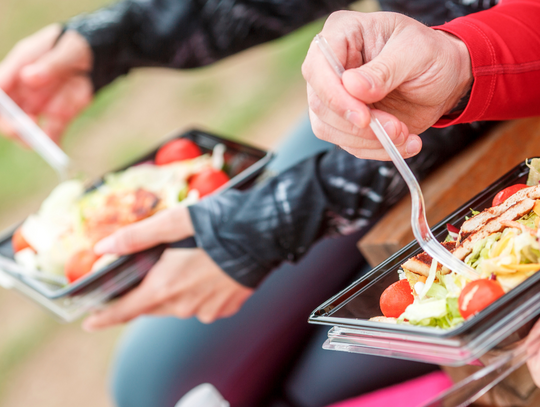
top-left (434, 0), bottom-right (540, 127)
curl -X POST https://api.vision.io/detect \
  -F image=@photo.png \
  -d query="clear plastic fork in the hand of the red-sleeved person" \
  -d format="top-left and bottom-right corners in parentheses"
top-left (315, 34), bottom-right (479, 280)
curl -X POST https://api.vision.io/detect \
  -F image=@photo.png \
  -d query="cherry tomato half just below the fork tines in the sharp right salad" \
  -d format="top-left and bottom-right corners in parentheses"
top-left (458, 279), bottom-right (504, 319)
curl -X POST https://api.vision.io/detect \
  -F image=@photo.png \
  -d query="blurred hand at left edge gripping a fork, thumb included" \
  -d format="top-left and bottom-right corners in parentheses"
top-left (0, 24), bottom-right (93, 142)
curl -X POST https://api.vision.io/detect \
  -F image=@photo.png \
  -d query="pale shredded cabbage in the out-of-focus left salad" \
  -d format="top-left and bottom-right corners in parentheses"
top-left (16, 155), bottom-right (213, 275)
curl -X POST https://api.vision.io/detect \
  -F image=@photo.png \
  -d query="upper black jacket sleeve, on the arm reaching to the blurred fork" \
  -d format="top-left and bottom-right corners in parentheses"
top-left (66, 0), bottom-right (352, 90)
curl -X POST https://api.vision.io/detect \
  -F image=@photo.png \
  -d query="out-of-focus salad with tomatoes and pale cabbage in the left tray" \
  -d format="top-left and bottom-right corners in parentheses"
top-left (12, 139), bottom-right (229, 284)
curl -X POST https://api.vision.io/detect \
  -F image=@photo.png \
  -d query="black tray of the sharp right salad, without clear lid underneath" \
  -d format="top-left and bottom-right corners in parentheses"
top-left (309, 162), bottom-right (540, 344)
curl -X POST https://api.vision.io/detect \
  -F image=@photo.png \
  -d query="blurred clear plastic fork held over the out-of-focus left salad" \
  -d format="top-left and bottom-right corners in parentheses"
top-left (0, 89), bottom-right (70, 180)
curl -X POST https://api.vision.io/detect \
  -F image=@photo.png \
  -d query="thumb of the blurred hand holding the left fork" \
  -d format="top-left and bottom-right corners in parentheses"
top-left (20, 31), bottom-right (92, 86)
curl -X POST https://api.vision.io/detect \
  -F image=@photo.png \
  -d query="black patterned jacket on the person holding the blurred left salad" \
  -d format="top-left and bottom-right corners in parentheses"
top-left (66, 0), bottom-right (496, 287)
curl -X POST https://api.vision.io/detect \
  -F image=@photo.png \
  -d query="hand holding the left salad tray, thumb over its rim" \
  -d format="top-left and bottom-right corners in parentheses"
top-left (83, 207), bottom-right (253, 331)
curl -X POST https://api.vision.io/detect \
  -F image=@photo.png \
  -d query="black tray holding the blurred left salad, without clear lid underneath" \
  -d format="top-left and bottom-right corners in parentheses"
top-left (0, 130), bottom-right (272, 299)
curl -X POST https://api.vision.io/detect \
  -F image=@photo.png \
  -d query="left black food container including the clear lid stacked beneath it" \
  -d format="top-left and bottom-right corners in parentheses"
top-left (0, 130), bottom-right (272, 322)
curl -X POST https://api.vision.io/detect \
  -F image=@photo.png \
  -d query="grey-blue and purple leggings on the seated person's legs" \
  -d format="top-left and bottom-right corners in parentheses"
top-left (108, 120), bottom-right (436, 407)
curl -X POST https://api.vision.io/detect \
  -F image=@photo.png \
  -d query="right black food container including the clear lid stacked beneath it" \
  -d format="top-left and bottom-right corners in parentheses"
top-left (309, 159), bottom-right (540, 366)
